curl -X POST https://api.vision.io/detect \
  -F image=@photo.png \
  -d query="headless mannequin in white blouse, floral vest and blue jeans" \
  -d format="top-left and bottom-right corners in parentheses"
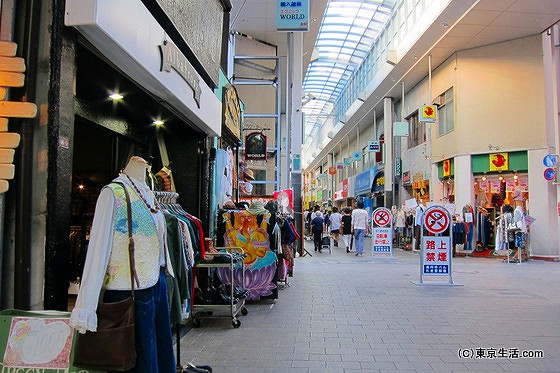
top-left (70, 156), bottom-right (176, 373)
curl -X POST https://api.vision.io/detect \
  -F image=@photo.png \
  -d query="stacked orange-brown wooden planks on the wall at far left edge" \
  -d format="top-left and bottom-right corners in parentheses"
top-left (0, 42), bottom-right (37, 193)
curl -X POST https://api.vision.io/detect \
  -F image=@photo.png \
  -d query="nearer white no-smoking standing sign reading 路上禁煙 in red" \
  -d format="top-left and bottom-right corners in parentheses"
top-left (415, 206), bottom-right (461, 285)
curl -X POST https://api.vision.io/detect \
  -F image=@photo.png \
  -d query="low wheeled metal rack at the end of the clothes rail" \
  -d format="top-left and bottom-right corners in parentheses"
top-left (192, 247), bottom-right (249, 328)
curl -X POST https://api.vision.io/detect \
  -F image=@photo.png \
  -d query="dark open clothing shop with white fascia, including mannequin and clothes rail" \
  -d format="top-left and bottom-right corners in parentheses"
top-left (61, 0), bottom-right (228, 372)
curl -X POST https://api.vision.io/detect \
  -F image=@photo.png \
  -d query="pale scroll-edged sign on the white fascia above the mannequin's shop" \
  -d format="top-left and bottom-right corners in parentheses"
top-left (159, 40), bottom-right (202, 109)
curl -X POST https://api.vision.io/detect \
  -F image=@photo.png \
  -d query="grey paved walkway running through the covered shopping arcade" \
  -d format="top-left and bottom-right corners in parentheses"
top-left (180, 239), bottom-right (560, 373)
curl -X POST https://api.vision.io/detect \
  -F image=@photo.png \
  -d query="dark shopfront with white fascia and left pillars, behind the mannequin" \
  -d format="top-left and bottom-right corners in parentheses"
top-left (2, 0), bottom-right (229, 310)
